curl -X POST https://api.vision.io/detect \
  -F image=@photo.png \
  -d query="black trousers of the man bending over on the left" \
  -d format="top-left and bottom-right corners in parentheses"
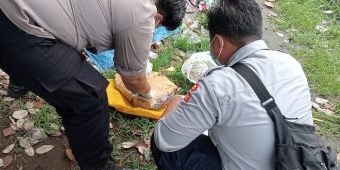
top-left (0, 11), bottom-right (112, 170)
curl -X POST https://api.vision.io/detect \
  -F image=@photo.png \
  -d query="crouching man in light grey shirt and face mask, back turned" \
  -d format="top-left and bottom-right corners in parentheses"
top-left (151, 0), bottom-right (313, 170)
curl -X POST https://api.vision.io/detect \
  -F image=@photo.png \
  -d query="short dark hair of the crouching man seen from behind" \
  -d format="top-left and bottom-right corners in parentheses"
top-left (208, 0), bottom-right (262, 45)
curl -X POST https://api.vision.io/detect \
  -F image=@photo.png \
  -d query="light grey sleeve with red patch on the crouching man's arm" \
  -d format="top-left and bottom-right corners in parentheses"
top-left (154, 79), bottom-right (217, 152)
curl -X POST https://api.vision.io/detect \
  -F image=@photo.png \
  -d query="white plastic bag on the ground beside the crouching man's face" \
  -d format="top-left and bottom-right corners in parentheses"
top-left (182, 51), bottom-right (217, 83)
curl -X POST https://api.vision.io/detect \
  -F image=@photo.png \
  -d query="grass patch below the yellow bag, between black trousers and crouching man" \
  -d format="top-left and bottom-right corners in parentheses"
top-left (110, 111), bottom-right (156, 170)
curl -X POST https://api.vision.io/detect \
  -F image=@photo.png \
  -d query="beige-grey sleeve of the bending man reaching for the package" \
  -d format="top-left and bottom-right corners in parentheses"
top-left (114, 25), bottom-right (154, 75)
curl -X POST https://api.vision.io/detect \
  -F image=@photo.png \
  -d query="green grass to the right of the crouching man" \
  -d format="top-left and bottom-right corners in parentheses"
top-left (274, 0), bottom-right (340, 137)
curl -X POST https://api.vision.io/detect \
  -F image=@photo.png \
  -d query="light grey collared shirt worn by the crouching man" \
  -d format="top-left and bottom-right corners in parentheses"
top-left (155, 40), bottom-right (313, 170)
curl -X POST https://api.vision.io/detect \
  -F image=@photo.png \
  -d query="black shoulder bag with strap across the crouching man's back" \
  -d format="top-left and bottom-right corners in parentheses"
top-left (232, 63), bottom-right (337, 170)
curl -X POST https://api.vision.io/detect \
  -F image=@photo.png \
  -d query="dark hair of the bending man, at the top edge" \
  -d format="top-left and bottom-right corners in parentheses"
top-left (156, 0), bottom-right (186, 30)
